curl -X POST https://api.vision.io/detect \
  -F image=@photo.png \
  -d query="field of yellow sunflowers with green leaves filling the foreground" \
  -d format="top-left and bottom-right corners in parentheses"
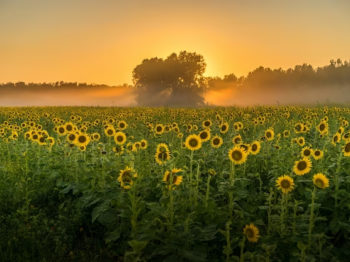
top-left (0, 106), bottom-right (350, 261)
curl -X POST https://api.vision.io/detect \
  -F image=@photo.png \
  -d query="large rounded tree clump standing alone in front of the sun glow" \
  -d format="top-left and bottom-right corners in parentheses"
top-left (133, 51), bottom-right (206, 106)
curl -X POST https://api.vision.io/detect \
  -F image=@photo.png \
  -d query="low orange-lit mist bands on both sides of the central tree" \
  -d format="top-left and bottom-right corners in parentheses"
top-left (0, 84), bottom-right (350, 106)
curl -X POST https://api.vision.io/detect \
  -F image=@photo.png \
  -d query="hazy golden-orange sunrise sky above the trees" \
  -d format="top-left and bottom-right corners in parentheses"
top-left (0, 0), bottom-right (350, 85)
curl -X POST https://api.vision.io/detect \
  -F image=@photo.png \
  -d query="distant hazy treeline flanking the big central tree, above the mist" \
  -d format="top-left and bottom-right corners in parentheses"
top-left (0, 59), bottom-right (350, 89)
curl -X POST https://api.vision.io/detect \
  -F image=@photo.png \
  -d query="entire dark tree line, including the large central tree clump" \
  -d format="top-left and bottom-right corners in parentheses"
top-left (0, 51), bottom-right (350, 106)
